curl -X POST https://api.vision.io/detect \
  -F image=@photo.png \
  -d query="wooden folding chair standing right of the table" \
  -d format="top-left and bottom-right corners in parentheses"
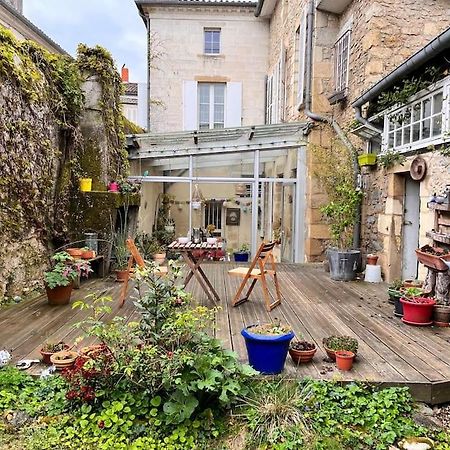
top-left (228, 242), bottom-right (281, 311)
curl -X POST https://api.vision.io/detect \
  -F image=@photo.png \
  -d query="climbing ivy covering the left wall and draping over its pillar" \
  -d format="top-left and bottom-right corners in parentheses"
top-left (0, 27), bottom-right (127, 243)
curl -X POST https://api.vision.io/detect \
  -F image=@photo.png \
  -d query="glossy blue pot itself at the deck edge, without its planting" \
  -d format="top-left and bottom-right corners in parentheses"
top-left (241, 327), bottom-right (295, 375)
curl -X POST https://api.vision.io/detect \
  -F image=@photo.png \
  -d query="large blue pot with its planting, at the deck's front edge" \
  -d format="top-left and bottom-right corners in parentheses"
top-left (241, 323), bottom-right (295, 374)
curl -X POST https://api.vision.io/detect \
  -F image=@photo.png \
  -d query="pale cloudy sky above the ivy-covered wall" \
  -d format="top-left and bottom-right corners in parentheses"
top-left (23, 0), bottom-right (147, 82)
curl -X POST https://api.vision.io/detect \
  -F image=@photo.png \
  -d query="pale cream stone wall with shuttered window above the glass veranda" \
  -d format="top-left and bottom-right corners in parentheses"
top-left (142, 6), bottom-right (269, 132)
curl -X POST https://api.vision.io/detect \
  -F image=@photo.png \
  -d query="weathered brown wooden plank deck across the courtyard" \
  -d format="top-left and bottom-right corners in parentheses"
top-left (0, 263), bottom-right (450, 404)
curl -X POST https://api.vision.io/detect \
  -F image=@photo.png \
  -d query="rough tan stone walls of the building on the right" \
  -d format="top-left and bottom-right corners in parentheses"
top-left (257, 0), bottom-right (450, 280)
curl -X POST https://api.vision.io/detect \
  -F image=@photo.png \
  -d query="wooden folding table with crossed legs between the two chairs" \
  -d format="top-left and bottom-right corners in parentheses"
top-left (169, 241), bottom-right (222, 303)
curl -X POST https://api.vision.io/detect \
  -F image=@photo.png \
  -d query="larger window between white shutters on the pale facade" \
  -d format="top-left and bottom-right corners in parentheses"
top-left (198, 83), bottom-right (225, 130)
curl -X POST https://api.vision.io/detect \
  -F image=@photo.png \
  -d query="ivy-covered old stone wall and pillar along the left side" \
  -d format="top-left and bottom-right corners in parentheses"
top-left (0, 27), bottom-right (128, 301)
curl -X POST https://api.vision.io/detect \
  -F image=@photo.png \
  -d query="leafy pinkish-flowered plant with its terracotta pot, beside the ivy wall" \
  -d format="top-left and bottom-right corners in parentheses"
top-left (44, 252), bottom-right (91, 305)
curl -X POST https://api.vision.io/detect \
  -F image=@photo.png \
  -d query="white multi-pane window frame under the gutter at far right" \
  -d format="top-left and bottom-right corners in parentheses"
top-left (382, 76), bottom-right (450, 153)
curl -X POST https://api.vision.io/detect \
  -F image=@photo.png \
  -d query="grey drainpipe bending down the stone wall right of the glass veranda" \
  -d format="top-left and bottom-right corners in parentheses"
top-left (297, 0), bottom-right (361, 249)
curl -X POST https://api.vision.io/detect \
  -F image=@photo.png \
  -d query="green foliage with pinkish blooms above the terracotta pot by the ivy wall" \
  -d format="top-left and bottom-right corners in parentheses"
top-left (44, 252), bottom-right (92, 289)
